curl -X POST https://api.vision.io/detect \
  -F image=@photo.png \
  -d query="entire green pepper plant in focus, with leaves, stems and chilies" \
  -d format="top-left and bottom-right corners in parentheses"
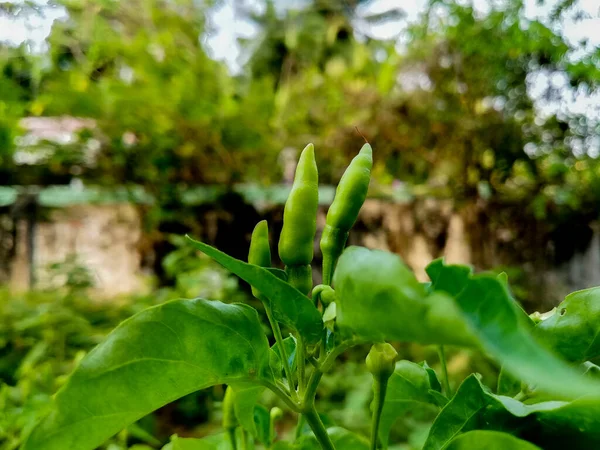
top-left (23, 144), bottom-right (600, 450)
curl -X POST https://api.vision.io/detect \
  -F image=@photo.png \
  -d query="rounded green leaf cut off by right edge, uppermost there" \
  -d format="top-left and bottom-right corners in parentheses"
top-left (536, 287), bottom-right (600, 362)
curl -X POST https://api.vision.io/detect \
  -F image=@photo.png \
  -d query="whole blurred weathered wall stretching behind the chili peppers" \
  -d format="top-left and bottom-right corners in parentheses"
top-left (2, 198), bottom-right (600, 309)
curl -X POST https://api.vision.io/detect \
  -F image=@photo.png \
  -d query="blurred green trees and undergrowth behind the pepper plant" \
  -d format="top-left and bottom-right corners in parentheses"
top-left (0, 0), bottom-right (600, 450)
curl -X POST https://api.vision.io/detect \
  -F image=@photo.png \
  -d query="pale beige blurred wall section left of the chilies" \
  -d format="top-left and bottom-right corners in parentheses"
top-left (10, 203), bottom-right (142, 297)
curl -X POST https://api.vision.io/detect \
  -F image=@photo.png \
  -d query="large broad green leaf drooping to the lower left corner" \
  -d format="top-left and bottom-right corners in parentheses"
top-left (23, 299), bottom-right (273, 450)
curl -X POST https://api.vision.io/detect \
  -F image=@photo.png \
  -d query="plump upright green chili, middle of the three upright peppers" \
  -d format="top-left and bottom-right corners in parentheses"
top-left (279, 144), bottom-right (319, 294)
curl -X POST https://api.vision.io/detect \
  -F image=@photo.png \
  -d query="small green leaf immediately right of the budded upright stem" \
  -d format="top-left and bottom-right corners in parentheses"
top-left (379, 360), bottom-right (439, 448)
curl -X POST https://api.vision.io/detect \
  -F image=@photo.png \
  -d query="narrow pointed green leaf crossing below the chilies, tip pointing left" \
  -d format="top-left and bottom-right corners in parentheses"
top-left (187, 236), bottom-right (323, 344)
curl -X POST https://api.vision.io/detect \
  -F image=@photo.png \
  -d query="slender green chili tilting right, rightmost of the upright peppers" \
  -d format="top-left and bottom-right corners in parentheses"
top-left (320, 144), bottom-right (373, 284)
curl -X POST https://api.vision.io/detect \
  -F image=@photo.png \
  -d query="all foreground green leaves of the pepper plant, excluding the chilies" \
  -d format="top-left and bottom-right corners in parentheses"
top-left (23, 241), bottom-right (600, 450)
